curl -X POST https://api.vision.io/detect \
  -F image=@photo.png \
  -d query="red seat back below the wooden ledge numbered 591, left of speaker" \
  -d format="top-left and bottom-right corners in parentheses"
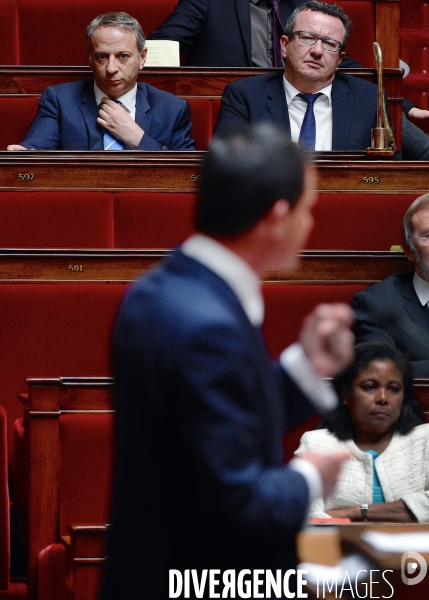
top-left (0, 283), bottom-right (127, 464)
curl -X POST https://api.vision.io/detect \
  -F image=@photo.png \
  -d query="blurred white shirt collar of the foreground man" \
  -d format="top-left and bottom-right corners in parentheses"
top-left (181, 233), bottom-right (264, 327)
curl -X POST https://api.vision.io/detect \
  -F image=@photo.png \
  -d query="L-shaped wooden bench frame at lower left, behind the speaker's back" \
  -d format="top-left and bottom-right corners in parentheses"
top-left (21, 377), bottom-right (113, 599)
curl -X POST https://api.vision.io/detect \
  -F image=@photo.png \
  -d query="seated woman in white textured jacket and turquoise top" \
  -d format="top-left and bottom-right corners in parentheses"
top-left (296, 342), bottom-right (429, 522)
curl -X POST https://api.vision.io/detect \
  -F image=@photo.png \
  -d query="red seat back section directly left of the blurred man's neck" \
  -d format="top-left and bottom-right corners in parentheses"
top-left (113, 192), bottom-right (197, 248)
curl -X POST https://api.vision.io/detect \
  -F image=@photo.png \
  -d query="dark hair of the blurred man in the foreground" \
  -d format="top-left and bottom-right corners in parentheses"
top-left (197, 123), bottom-right (306, 236)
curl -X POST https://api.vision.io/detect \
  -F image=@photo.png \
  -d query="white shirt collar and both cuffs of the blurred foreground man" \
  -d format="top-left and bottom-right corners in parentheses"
top-left (181, 233), bottom-right (337, 503)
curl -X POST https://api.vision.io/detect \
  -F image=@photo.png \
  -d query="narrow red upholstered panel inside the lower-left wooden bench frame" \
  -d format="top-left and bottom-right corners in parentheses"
top-left (59, 413), bottom-right (115, 535)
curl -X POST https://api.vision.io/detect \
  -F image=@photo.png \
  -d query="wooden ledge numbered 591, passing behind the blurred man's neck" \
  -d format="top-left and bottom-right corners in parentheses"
top-left (0, 249), bottom-right (413, 285)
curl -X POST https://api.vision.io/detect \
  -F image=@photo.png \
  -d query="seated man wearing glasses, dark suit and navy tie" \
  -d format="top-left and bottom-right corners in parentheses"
top-left (216, 1), bottom-right (388, 151)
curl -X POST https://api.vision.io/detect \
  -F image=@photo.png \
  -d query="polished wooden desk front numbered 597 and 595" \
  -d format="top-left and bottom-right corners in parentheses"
top-left (0, 150), bottom-right (429, 194)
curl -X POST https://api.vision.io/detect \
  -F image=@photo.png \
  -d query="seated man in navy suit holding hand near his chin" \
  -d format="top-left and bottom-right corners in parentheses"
top-left (8, 13), bottom-right (195, 150)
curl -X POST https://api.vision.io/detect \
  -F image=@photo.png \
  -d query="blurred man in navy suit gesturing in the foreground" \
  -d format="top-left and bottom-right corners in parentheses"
top-left (103, 126), bottom-right (353, 600)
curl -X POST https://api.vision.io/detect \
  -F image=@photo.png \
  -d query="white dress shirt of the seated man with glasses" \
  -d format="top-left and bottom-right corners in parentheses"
top-left (283, 77), bottom-right (332, 151)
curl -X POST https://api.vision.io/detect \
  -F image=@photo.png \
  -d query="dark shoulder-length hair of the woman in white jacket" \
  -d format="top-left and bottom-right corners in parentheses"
top-left (318, 342), bottom-right (424, 440)
